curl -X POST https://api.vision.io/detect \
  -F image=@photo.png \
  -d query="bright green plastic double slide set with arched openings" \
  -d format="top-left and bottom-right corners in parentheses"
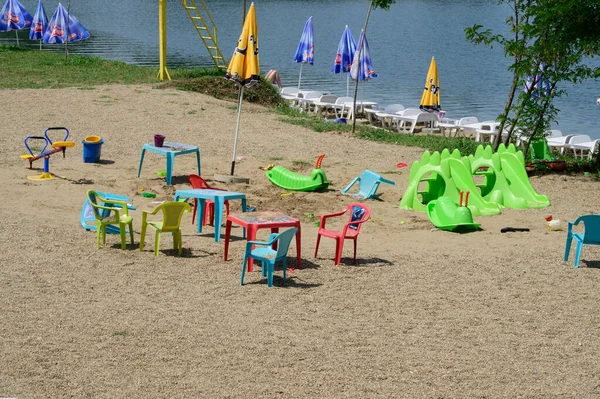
top-left (400, 144), bottom-right (550, 216)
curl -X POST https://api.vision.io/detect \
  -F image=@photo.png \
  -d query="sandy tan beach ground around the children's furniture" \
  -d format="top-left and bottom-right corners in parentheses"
top-left (0, 85), bottom-right (600, 399)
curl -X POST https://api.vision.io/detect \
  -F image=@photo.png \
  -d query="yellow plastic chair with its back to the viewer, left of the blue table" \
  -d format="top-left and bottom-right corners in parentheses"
top-left (140, 202), bottom-right (192, 256)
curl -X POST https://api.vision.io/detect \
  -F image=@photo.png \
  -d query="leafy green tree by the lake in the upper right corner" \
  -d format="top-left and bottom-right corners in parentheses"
top-left (465, 0), bottom-right (600, 159)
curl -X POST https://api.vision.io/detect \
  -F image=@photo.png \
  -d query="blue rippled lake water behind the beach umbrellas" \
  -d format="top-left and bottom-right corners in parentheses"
top-left (0, 0), bottom-right (600, 138)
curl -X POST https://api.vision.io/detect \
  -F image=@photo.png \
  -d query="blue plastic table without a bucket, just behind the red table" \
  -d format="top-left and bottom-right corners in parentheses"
top-left (174, 188), bottom-right (246, 242)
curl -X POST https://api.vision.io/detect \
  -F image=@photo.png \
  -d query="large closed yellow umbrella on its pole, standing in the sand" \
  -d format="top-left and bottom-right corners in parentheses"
top-left (225, 3), bottom-right (260, 176)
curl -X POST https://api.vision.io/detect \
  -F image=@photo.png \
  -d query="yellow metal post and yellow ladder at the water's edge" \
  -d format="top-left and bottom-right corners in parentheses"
top-left (158, 0), bottom-right (228, 80)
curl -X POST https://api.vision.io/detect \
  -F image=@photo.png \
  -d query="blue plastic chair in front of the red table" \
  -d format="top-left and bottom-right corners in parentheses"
top-left (240, 227), bottom-right (298, 287)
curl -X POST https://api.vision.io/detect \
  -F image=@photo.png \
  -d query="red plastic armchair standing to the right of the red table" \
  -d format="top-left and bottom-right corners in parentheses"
top-left (315, 202), bottom-right (371, 265)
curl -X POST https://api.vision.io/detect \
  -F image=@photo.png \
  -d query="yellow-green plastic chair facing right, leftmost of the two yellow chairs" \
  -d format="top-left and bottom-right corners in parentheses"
top-left (87, 190), bottom-right (133, 249)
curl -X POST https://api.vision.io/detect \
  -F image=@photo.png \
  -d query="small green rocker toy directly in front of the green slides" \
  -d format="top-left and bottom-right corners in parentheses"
top-left (427, 197), bottom-right (480, 232)
